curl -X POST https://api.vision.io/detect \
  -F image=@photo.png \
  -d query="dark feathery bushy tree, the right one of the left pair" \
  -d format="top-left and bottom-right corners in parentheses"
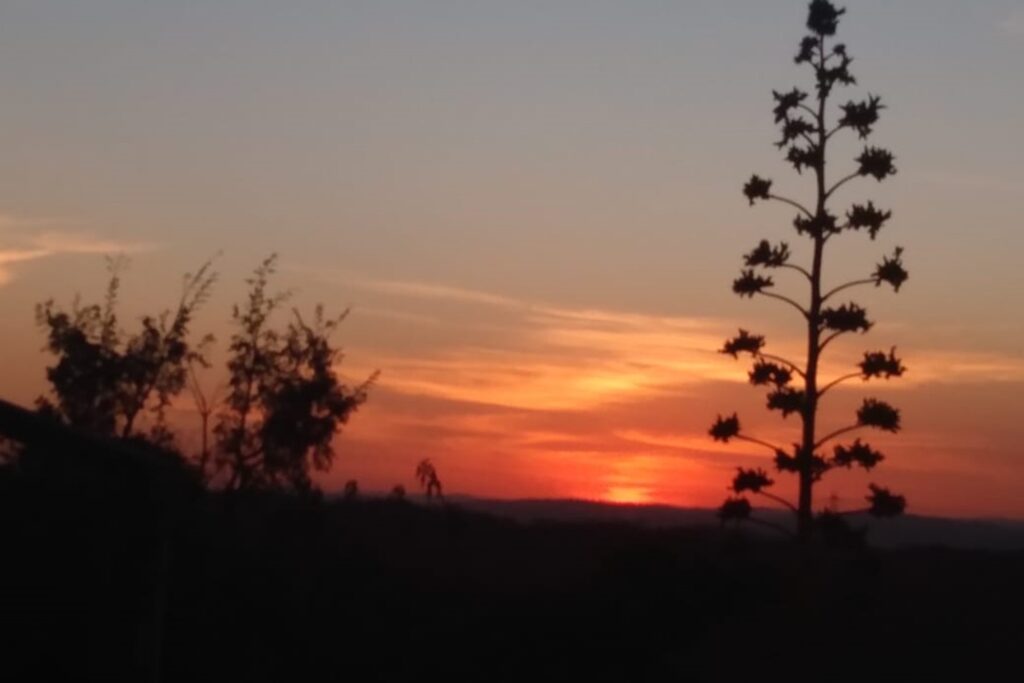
top-left (214, 256), bottom-right (376, 490)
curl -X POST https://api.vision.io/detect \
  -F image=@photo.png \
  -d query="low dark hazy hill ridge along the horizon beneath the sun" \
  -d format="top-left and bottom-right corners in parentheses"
top-left (440, 496), bottom-right (1024, 550)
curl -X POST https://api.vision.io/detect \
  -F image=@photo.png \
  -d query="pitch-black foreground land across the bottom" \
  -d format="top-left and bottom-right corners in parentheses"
top-left (0, 446), bottom-right (1024, 681)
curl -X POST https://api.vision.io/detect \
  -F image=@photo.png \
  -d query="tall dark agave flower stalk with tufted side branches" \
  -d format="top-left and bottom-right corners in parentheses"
top-left (711, 0), bottom-right (907, 539)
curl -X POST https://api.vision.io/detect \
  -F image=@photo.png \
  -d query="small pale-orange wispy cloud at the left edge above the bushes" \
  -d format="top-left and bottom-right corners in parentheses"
top-left (0, 224), bottom-right (153, 286)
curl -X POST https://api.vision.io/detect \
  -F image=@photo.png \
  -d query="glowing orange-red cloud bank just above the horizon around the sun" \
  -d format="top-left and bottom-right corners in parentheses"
top-left (301, 272), bottom-right (1024, 514)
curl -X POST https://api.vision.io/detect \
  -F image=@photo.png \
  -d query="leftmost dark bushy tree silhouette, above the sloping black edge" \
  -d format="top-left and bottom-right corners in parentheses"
top-left (36, 259), bottom-right (216, 442)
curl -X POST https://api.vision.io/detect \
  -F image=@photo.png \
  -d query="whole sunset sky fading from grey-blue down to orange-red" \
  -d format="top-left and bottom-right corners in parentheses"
top-left (0, 0), bottom-right (1024, 518)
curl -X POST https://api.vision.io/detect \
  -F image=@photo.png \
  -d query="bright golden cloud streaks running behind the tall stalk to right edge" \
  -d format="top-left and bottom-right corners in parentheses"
top-left (315, 273), bottom-right (1024, 412)
